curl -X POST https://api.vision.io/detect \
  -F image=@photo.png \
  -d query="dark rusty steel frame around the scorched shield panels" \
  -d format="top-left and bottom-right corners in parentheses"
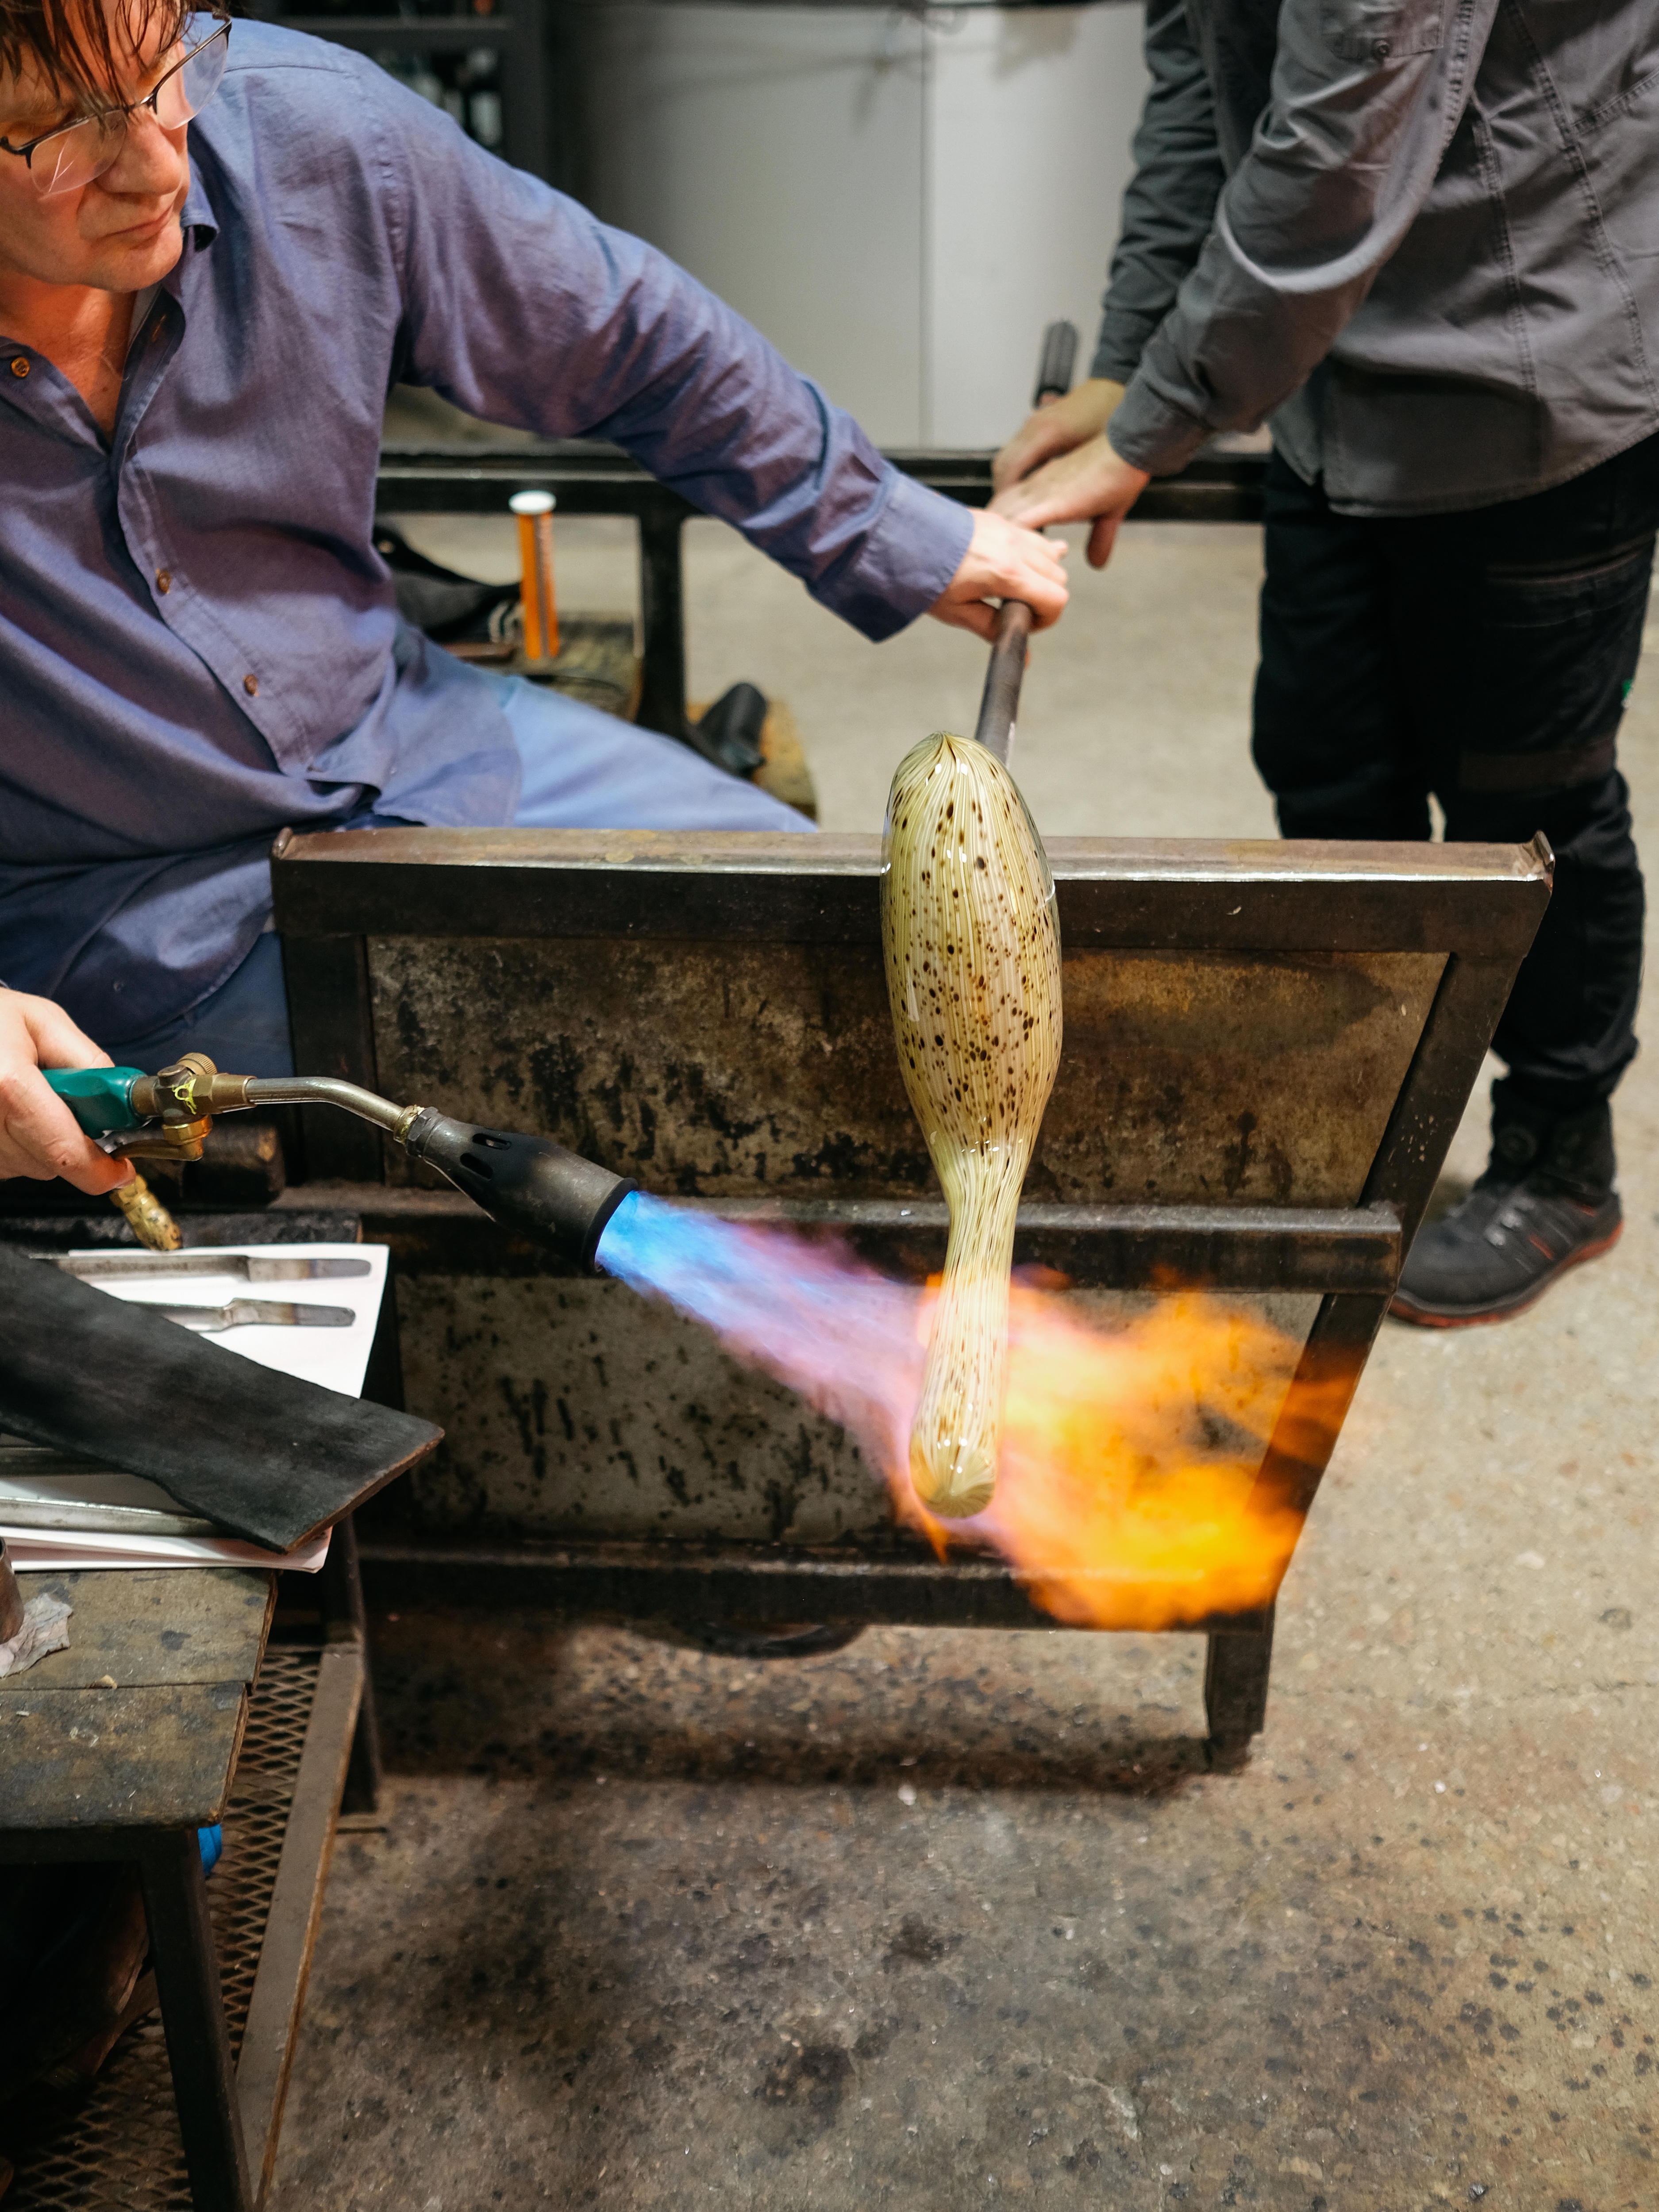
top-left (272, 830), bottom-right (1551, 1756)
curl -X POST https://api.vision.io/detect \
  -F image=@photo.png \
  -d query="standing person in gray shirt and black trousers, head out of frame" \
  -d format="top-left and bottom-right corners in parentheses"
top-left (995, 0), bottom-right (1659, 1327)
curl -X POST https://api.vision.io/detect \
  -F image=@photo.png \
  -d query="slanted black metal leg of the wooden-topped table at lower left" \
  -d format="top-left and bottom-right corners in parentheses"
top-left (135, 1827), bottom-right (254, 2212)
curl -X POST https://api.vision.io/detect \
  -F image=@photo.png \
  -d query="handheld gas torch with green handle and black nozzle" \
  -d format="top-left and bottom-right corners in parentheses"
top-left (42, 1053), bottom-right (635, 1267)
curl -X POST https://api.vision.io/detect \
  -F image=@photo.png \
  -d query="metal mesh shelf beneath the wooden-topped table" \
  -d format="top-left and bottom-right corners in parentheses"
top-left (7, 1646), bottom-right (323, 2212)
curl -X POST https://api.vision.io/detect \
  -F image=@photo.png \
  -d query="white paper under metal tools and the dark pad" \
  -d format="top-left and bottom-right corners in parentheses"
top-left (0, 1243), bottom-right (387, 1575)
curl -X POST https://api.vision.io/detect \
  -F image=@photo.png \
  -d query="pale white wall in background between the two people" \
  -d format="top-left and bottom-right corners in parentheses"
top-left (573, 0), bottom-right (1146, 447)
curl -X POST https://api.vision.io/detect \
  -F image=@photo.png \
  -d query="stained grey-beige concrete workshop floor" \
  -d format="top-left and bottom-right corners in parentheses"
top-left (272, 507), bottom-right (1659, 2212)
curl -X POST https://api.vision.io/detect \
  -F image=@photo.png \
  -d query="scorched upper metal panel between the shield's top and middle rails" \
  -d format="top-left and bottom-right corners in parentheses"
top-left (370, 938), bottom-right (1444, 1206)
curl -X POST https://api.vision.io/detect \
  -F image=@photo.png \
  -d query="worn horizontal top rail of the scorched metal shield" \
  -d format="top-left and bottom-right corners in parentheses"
top-left (272, 830), bottom-right (1544, 942)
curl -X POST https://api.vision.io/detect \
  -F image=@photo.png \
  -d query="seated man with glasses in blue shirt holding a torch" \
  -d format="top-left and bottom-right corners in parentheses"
top-left (0, 0), bottom-right (1066, 1190)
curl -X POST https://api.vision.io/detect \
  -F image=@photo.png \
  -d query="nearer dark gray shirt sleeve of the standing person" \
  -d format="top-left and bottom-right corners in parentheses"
top-left (1110, 0), bottom-right (1497, 476)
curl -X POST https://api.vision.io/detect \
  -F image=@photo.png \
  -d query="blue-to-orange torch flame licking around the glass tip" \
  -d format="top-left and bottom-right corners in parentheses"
top-left (600, 1194), bottom-right (1358, 1628)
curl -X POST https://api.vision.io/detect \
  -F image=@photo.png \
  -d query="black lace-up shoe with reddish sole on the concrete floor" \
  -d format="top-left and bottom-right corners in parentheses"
top-left (1389, 1082), bottom-right (1624, 1329)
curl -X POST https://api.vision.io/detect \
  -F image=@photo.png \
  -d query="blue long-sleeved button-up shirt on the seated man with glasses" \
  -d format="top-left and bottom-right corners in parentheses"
top-left (0, 20), bottom-right (971, 1046)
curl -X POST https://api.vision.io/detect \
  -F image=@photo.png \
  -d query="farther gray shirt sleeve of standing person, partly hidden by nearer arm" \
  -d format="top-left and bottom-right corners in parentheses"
top-left (1088, 0), bottom-right (1225, 385)
